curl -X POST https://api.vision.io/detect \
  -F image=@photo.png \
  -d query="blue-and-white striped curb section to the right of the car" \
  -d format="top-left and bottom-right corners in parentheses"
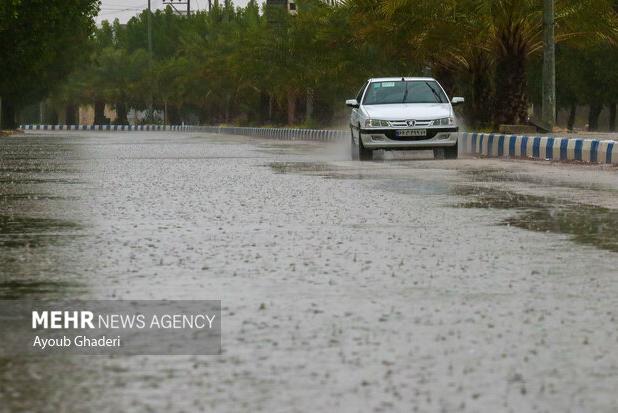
top-left (459, 132), bottom-right (618, 164)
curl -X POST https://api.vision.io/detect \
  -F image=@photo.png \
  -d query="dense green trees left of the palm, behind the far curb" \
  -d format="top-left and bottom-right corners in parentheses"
top-left (53, 1), bottom-right (366, 124)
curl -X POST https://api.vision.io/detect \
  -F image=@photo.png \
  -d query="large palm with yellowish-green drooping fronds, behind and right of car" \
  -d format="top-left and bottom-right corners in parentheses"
top-left (347, 0), bottom-right (618, 125)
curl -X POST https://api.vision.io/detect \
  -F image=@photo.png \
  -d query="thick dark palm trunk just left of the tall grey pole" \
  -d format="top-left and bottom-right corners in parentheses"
top-left (494, 47), bottom-right (528, 126)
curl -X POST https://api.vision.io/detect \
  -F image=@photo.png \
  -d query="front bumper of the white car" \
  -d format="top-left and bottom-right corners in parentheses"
top-left (360, 128), bottom-right (459, 149)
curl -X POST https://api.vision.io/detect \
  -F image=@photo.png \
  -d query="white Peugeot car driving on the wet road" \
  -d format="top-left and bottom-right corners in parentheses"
top-left (346, 77), bottom-right (464, 161)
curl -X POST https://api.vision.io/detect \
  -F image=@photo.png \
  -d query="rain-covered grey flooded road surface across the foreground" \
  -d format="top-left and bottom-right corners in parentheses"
top-left (0, 132), bottom-right (618, 412)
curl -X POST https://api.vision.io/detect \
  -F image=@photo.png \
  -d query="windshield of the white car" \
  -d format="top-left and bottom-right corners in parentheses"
top-left (363, 80), bottom-right (448, 105)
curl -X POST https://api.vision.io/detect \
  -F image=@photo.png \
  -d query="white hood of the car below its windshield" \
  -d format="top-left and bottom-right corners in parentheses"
top-left (363, 103), bottom-right (452, 120)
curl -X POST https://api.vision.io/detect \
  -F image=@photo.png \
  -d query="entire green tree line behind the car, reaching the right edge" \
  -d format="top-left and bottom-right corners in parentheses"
top-left (3, 0), bottom-right (618, 128)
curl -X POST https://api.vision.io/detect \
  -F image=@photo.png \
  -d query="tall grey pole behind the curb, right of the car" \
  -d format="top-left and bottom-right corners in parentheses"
top-left (543, 0), bottom-right (556, 131)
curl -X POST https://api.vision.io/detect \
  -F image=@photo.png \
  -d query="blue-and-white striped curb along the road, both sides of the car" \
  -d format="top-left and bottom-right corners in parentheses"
top-left (20, 125), bottom-right (618, 164)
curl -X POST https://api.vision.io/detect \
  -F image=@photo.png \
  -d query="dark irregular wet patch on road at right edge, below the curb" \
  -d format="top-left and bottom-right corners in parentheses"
top-left (453, 186), bottom-right (618, 252)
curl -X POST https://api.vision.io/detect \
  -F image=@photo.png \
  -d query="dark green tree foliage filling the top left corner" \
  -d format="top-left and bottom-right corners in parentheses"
top-left (0, 0), bottom-right (99, 126)
